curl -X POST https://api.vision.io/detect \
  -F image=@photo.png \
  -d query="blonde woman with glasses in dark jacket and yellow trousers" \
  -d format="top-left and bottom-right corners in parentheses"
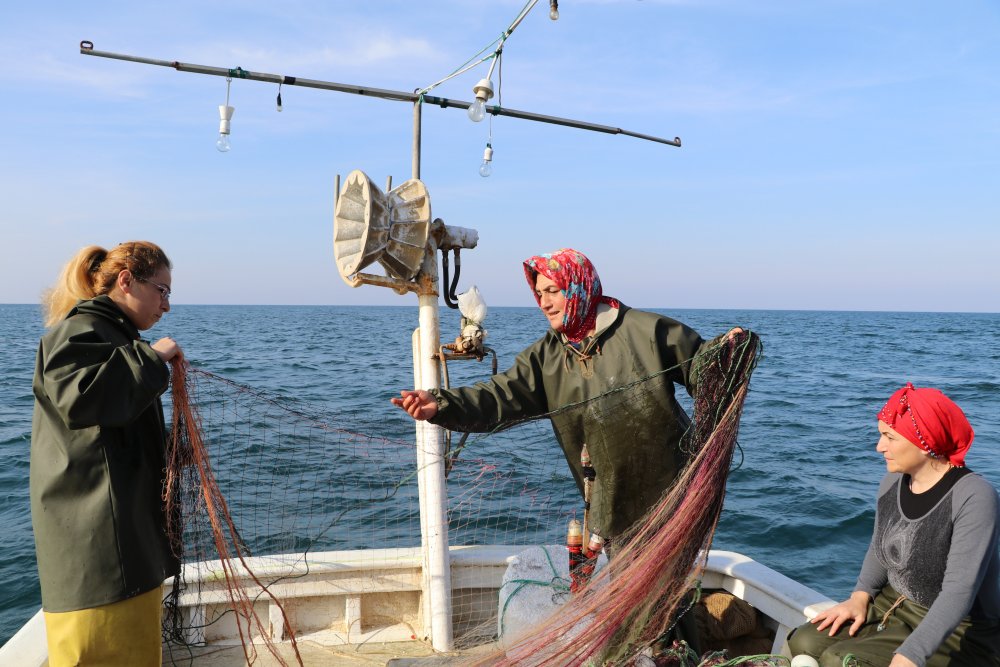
top-left (30, 241), bottom-right (182, 667)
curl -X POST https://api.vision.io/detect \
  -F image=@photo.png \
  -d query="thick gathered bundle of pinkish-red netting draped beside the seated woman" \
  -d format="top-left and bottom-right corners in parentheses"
top-left (480, 332), bottom-right (760, 666)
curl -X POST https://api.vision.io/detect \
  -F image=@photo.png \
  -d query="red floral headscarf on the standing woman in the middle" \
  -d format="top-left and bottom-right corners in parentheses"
top-left (524, 248), bottom-right (619, 343)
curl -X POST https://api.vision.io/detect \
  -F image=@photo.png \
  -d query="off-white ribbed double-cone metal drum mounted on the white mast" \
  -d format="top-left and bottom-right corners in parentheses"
top-left (333, 169), bottom-right (431, 287)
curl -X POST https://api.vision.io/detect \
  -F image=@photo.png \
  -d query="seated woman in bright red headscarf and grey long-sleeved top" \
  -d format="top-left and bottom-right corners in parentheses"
top-left (789, 384), bottom-right (1000, 667)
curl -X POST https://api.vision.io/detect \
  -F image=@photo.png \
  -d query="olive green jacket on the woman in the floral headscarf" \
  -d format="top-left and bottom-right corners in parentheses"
top-left (431, 305), bottom-right (707, 538)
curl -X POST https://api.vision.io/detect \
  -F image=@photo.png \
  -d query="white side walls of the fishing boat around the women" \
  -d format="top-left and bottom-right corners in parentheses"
top-left (0, 546), bottom-right (833, 667)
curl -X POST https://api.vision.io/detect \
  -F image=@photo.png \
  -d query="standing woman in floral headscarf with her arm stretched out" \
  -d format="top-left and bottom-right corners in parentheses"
top-left (392, 248), bottom-right (744, 540)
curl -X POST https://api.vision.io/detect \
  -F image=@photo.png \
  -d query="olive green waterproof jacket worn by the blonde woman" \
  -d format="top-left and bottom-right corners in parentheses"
top-left (30, 296), bottom-right (178, 612)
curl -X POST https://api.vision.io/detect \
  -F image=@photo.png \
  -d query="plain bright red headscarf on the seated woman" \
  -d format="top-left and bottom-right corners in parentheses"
top-left (878, 382), bottom-right (976, 467)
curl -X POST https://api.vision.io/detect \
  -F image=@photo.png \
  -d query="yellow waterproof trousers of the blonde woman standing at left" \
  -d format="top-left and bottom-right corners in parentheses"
top-left (45, 588), bottom-right (163, 667)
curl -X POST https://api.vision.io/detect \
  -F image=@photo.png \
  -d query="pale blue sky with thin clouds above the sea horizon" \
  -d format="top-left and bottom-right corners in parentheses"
top-left (0, 0), bottom-right (1000, 312)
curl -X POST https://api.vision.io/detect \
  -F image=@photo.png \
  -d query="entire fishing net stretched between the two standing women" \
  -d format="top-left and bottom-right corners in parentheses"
top-left (165, 333), bottom-right (760, 665)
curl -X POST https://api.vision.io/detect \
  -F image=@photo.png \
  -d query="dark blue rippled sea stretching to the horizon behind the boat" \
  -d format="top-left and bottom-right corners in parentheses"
top-left (0, 305), bottom-right (1000, 643)
